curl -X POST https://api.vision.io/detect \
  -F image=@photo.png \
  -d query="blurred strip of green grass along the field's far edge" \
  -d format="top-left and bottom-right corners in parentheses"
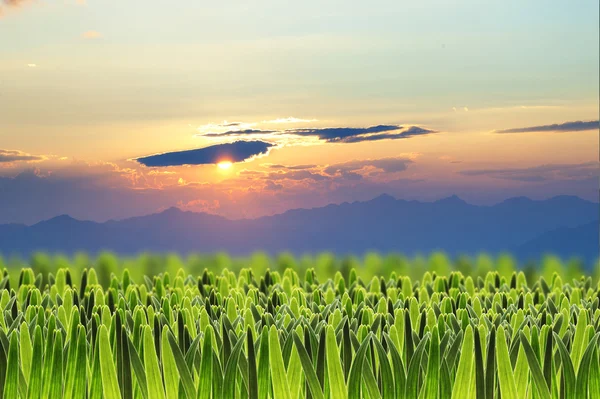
top-left (0, 252), bottom-right (600, 286)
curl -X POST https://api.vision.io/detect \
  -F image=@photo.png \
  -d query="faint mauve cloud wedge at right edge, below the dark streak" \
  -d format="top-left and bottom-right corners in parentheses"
top-left (459, 162), bottom-right (599, 183)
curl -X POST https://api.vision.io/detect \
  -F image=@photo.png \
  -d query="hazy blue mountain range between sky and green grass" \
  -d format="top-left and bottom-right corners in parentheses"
top-left (0, 195), bottom-right (599, 262)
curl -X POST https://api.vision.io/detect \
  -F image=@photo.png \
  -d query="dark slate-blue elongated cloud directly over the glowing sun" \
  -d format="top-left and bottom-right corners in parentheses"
top-left (136, 141), bottom-right (275, 167)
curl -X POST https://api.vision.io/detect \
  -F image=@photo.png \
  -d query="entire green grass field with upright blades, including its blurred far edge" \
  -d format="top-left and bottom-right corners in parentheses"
top-left (0, 254), bottom-right (600, 399)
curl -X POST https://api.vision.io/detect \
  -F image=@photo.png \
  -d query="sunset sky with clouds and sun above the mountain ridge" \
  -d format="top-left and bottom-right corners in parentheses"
top-left (0, 0), bottom-right (600, 224)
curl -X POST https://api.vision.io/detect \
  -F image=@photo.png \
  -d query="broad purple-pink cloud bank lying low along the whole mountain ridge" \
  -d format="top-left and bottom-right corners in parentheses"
top-left (0, 154), bottom-right (599, 223)
